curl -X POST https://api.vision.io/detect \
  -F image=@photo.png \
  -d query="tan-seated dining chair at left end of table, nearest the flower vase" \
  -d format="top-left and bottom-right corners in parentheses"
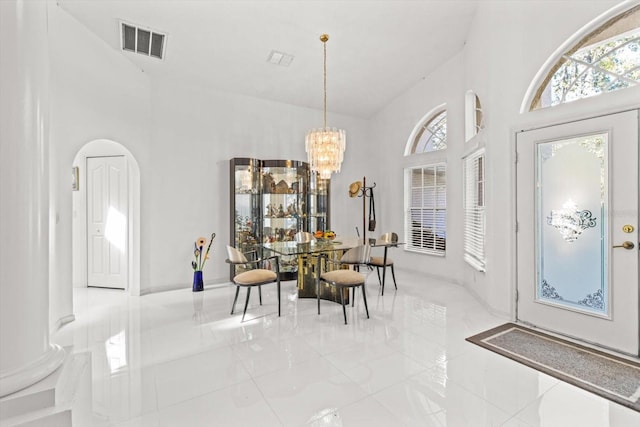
top-left (226, 245), bottom-right (280, 322)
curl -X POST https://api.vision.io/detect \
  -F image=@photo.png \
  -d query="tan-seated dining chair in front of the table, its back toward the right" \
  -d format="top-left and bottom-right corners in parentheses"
top-left (316, 245), bottom-right (371, 325)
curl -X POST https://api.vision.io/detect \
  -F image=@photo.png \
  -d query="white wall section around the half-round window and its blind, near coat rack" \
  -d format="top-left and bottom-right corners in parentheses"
top-left (371, 54), bottom-right (465, 284)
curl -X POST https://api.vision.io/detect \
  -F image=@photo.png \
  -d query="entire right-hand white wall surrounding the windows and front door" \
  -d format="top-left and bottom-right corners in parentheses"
top-left (372, 1), bottom-right (640, 314)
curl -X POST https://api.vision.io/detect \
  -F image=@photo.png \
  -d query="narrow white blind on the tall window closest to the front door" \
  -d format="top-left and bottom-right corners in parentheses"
top-left (464, 150), bottom-right (485, 271)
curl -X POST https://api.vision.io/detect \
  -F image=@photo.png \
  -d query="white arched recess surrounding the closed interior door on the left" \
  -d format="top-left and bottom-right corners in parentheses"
top-left (72, 139), bottom-right (140, 295)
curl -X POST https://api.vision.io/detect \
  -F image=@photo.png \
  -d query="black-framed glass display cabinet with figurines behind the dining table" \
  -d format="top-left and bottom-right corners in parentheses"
top-left (229, 158), bottom-right (330, 280)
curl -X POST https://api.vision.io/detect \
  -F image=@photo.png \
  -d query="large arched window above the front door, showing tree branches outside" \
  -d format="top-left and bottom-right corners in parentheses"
top-left (528, 6), bottom-right (640, 111)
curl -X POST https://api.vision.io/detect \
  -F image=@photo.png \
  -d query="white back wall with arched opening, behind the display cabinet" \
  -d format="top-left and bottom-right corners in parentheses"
top-left (49, 5), bottom-right (374, 300)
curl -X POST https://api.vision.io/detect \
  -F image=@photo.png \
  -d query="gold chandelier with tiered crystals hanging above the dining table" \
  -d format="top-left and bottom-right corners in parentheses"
top-left (305, 34), bottom-right (346, 179)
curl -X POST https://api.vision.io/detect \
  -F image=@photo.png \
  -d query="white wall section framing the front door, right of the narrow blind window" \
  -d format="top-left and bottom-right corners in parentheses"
top-left (465, 1), bottom-right (629, 313)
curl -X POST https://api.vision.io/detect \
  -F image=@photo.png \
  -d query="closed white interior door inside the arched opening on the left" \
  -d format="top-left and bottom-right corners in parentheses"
top-left (87, 156), bottom-right (128, 289)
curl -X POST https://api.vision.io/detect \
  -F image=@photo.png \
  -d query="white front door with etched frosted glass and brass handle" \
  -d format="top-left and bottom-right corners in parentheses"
top-left (516, 111), bottom-right (639, 355)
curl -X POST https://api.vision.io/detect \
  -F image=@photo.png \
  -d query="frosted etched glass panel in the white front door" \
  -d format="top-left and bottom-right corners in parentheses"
top-left (536, 134), bottom-right (610, 316)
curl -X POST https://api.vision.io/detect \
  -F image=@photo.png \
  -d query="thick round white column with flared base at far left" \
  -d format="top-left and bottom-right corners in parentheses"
top-left (0, 0), bottom-right (64, 397)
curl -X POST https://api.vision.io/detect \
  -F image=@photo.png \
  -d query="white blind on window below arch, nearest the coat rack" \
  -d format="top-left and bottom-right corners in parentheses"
top-left (405, 163), bottom-right (447, 255)
